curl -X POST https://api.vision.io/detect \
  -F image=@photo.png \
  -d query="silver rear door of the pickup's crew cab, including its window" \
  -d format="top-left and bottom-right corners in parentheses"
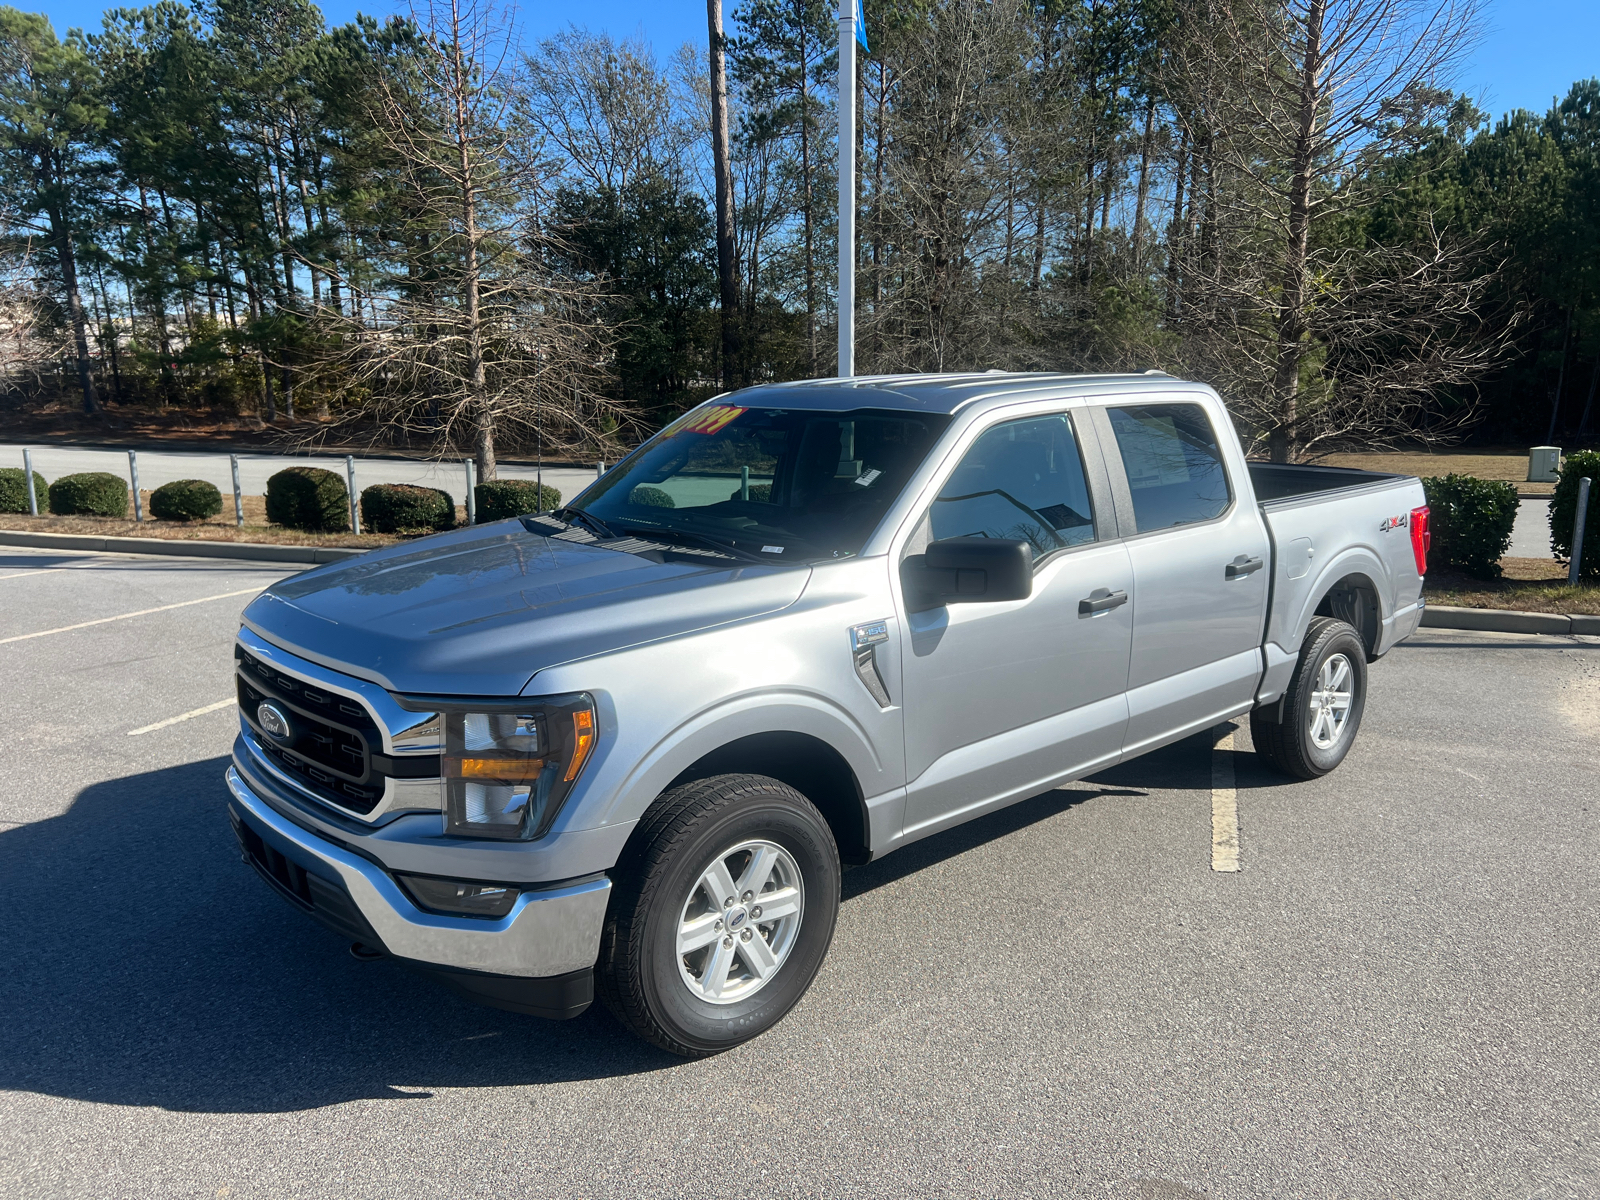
top-left (1091, 402), bottom-right (1272, 755)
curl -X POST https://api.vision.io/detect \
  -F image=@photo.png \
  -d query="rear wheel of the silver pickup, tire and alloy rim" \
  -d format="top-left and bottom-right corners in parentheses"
top-left (1250, 616), bottom-right (1366, 779)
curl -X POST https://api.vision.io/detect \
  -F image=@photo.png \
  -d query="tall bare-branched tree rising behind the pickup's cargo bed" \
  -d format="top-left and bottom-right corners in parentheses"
top-left (1168, 0), bottom-right (1498, 462)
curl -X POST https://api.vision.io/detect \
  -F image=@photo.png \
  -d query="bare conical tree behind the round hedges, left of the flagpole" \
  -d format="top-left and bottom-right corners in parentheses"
top-left (310, 0), bottom-right (618, 482)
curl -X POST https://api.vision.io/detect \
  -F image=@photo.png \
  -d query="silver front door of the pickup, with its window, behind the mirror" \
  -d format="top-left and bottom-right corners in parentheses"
top-left (896, 411), bottom-right (1134, 837)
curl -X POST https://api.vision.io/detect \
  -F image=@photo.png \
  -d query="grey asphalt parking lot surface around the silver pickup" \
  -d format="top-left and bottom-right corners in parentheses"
top-left (0, 552), bottom-right (1600, 1200)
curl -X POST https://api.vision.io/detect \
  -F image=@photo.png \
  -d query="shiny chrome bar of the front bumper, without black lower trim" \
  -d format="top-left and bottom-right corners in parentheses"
top-left (227, 766), bottom-right (611, 978)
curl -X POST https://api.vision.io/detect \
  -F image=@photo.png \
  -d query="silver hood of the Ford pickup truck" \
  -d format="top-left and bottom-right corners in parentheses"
top-left (245, 520), bottom-right (811, 696)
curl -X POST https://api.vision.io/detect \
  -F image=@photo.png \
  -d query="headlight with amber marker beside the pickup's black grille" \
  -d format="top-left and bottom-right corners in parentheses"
top-left (442, 694), bottom-right (597, 838)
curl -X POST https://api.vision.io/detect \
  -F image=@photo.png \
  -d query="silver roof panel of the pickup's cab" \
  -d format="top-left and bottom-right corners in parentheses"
top-left (712, 371), bottom-right (1195, 413)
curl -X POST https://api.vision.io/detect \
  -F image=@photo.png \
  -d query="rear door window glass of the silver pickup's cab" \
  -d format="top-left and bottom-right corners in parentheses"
top-left (1107, 405), bottom-right (1230, 533)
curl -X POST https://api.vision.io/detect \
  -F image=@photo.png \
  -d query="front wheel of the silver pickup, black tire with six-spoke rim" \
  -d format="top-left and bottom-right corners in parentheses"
top-left (597, 774), bottom-right (840, 1058)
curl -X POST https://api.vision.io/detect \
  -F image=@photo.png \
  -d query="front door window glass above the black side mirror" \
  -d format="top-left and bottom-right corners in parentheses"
top-left (928, 414), bottom-right (1094, 558)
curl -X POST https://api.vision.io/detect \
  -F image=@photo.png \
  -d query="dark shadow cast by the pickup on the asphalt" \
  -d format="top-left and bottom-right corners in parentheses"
top-left (0, 739), bottom-right (1260, 1112)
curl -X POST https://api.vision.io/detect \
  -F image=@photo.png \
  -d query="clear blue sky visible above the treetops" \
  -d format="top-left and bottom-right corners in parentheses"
top-left (31, 0), bottom-right (1600, 117)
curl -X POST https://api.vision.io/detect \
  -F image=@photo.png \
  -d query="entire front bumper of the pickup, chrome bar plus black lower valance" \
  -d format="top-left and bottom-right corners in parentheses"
top-left (227, 766), bottom-right (611, 1016)
